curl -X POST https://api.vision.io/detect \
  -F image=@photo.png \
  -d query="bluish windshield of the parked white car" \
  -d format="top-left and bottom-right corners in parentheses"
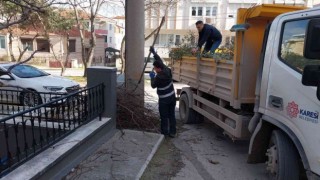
top-left (5, 65), bottom-right (49, 78)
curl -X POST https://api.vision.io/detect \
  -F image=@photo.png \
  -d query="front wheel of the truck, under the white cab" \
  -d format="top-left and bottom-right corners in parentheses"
top-left (266, 130), bottom-right (299, 180)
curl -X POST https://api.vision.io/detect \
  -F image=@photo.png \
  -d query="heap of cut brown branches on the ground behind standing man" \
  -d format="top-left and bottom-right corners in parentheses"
top-left (117, 87), bottom-right (160, 133)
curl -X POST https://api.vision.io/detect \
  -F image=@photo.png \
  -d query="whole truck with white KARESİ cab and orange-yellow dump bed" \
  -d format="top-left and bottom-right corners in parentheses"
top-left (172, 5), bottom-right (320, 180)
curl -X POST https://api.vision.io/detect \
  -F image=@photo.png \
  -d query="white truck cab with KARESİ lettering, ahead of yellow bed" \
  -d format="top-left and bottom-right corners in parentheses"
top-left (249, 6), bottom-right (320, 179)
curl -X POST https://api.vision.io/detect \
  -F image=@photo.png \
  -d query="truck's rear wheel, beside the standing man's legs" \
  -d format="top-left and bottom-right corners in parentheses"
top-left (179, 94), bottom-right (199, 124)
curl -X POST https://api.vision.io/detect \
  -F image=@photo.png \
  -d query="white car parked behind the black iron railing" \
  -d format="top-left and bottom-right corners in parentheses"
top-left (0, 64), bottom-right (80, 106)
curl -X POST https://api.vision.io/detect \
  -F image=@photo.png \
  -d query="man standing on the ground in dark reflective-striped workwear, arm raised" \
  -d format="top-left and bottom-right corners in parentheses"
top-left (149, 46), bottom-right (176, 137)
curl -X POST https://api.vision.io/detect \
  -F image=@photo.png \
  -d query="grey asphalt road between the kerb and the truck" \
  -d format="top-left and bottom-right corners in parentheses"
top-left (142, 84), bottom-right (268, 180)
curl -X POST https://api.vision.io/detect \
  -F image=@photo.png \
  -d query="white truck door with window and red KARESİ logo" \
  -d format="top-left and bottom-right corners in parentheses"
top-left (265, 11), bottom-right (320, 173)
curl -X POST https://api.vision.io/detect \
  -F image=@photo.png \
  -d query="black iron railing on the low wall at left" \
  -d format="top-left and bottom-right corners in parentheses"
top-left (0, 84), bottom-right (104, 178)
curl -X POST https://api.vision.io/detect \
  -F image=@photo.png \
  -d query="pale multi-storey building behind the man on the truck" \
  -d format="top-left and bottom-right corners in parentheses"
top-left (145, 0), bottom-right (318, 57)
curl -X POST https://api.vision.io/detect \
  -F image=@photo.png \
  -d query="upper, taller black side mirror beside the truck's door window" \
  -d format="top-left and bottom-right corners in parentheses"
top-left (303, 19), bottom-right (320, 59)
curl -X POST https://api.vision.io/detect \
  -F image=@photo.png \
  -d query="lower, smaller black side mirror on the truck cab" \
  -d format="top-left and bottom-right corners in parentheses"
top-left (302, 65), bottom-right (320, 100)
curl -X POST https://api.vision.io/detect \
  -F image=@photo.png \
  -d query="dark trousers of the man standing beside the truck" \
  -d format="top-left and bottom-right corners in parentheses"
top-left (159, 95), bottom-right (176, 135)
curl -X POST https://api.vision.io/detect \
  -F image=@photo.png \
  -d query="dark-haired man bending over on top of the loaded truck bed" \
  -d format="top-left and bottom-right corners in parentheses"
top-left (192, 21), bottom-right (222, 55)
